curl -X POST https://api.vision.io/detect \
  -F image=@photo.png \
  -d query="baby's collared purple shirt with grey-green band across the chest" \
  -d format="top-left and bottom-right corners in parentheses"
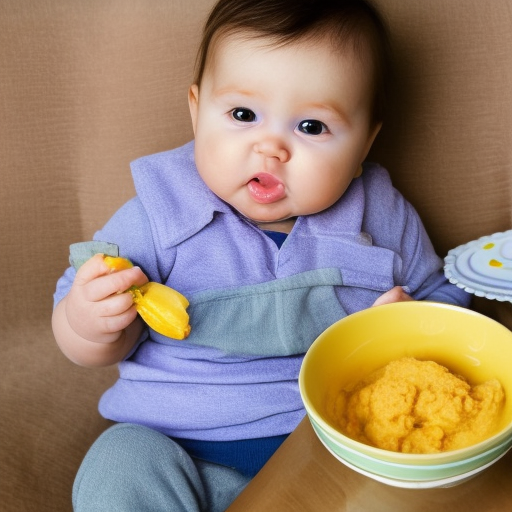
top-left (55, 142), bottom-right (469, 441)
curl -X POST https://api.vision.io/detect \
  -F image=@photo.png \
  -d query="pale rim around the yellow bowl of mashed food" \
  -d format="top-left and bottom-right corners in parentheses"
top-left (298, 301), bottom-right (512, 466)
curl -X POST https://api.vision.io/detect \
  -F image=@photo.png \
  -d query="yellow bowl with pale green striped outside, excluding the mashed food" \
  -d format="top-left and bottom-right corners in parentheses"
top-left (299, 302), bottom-right (512, 487)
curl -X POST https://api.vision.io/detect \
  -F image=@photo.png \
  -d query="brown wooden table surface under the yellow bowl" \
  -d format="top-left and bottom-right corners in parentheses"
top-left (228, 418), bottom-right (512, 512)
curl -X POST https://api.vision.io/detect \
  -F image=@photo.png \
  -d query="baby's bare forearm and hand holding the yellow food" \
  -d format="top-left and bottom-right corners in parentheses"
top-left (52, 254), bottom-right (148, 367)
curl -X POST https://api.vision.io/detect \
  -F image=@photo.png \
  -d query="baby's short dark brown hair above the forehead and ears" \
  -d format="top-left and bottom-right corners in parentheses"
top-left (194, 0), bottom-right (391, 122)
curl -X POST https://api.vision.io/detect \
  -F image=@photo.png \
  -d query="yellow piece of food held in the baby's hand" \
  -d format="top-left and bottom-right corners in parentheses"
top-left (104, 256), bottom-right (190, 340)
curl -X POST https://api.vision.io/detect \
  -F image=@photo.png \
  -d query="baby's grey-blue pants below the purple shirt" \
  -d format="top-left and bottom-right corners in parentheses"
top-left (73, 424), bottom-right (250, 512)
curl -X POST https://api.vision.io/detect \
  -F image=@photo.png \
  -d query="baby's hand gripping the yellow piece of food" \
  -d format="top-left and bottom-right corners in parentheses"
top-left (66, 254), bottom-right (148, 343)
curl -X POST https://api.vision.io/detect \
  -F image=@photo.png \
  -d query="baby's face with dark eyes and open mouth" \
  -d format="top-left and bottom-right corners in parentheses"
top-left (189, 35), bottom-right (380, 229)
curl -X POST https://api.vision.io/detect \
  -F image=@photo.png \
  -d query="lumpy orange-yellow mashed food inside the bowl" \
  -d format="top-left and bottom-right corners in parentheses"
top-left (330, 357), bottom-right (505, 453)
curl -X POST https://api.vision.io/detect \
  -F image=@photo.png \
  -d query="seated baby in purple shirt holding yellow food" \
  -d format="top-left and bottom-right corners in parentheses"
top-left (53, 0), bottom-right (468, 512)
